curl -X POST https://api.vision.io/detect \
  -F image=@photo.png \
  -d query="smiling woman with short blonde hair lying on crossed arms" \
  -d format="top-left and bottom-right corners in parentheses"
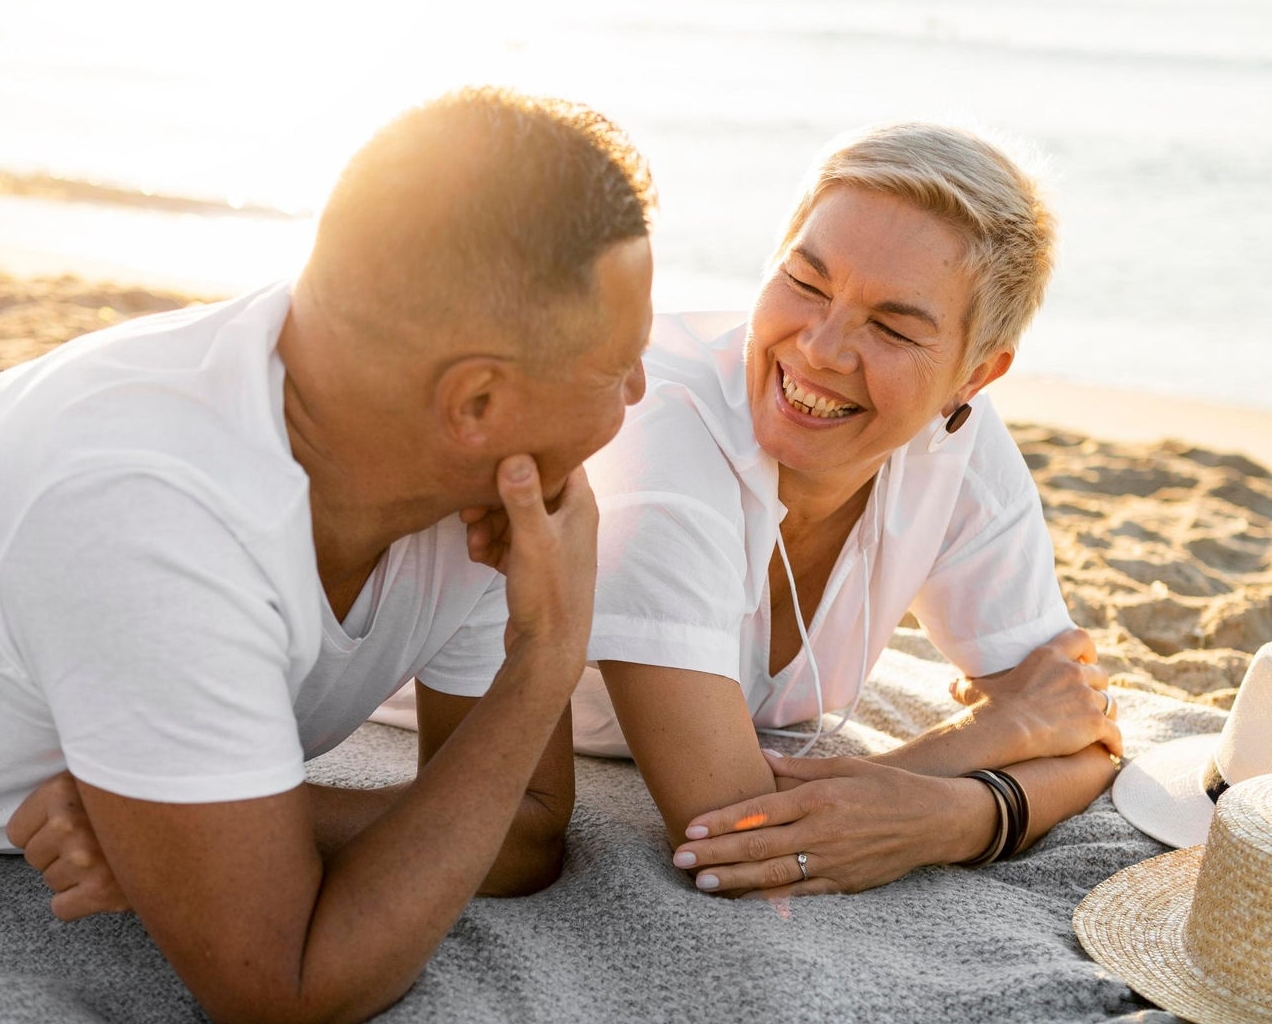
top-left (575, 125), bottom-right (1121, 897)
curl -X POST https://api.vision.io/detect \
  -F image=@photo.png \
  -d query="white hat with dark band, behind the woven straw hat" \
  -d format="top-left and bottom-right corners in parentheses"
top-left (1113, 644), bottom-right (1272, 847)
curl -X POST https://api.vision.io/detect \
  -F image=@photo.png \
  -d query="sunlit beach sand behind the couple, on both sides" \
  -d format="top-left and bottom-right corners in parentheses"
top-left (7, 275), bottom-right (1272, 707)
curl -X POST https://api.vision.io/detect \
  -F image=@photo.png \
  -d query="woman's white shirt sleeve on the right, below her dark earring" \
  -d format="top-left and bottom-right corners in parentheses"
top-left (912, 427), bottom-right (1074, 675)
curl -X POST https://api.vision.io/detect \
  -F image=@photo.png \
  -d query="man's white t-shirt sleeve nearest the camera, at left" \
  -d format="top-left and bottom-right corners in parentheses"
top-left (0, 474), bottom-right (304, 803)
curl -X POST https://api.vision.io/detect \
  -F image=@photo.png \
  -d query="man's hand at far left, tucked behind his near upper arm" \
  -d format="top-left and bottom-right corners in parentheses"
top-left (5, 772), bottom-right (131, 921)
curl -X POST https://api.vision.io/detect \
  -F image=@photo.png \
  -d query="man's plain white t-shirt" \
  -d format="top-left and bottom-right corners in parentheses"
top-left (0, 285), bottom-right (506, 848)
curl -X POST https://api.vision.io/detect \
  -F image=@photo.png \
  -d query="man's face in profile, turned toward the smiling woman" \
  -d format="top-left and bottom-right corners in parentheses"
top-left (514, 238), bottom-right (654, 497)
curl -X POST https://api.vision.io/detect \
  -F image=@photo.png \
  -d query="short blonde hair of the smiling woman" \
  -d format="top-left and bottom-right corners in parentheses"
top-left (776, 123), bottom-right (1056, 366)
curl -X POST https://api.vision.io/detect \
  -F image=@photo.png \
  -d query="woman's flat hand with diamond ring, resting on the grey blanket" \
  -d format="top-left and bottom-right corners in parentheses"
top-left (673, 757), bottom-right (997, 899)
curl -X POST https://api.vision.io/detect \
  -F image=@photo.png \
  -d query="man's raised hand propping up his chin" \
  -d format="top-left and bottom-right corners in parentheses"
top-left (460, 455), bottom-right (598, 661)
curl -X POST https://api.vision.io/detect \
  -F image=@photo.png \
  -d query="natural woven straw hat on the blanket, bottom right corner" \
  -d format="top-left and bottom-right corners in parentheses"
top-left (1074, 775), bottom-right (1272, 1024)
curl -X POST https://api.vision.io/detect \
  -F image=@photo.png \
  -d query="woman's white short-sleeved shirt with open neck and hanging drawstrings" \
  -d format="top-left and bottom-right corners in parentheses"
top-left (574, 314), bottom-right (1072, 754)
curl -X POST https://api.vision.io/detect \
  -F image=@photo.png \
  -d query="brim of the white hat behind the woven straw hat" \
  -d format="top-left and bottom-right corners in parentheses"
top-left (1113, 733), bottom-right (1219, 848)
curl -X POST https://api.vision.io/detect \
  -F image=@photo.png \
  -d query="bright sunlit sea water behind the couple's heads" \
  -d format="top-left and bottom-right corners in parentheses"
top-left (0, 0), bottom-right (1272, 408)
